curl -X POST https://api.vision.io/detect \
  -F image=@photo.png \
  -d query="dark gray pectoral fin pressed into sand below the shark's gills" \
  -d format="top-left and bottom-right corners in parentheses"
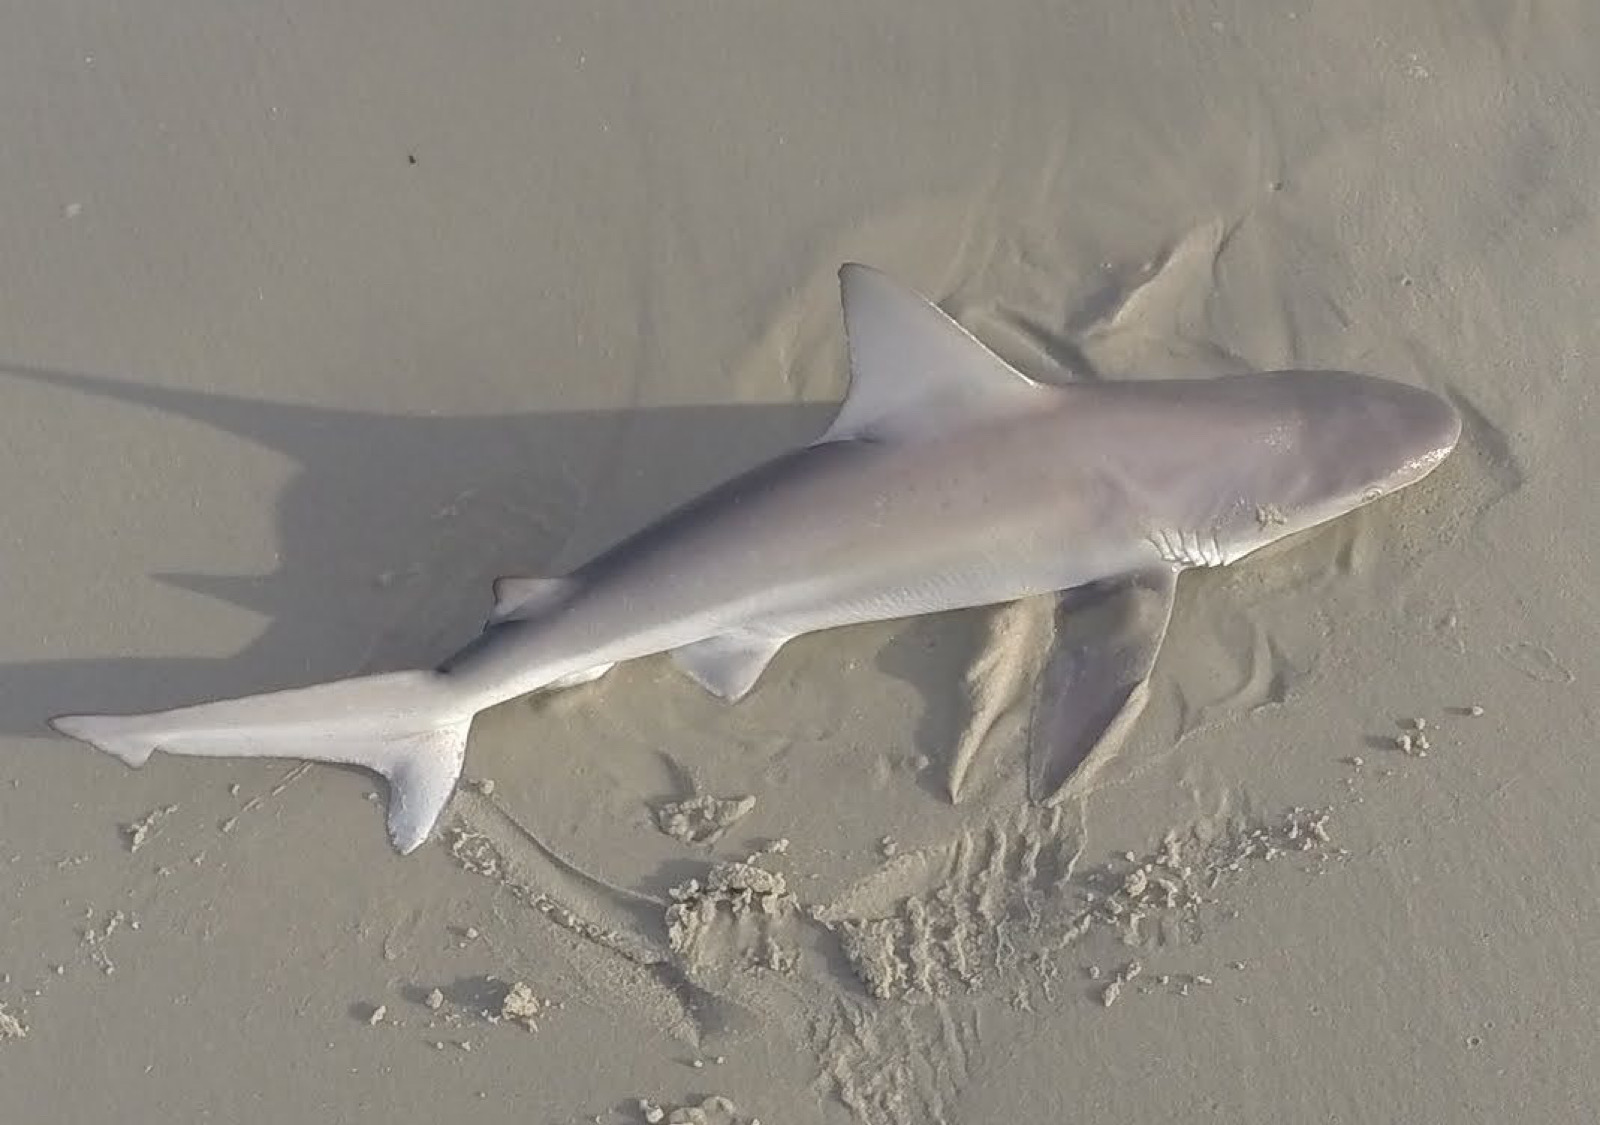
top-left (1027, 568), bottom-right (1178, 805)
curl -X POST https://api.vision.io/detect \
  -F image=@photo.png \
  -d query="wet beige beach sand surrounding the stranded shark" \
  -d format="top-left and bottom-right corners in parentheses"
top-left (0, 0), bottom-right (1600, 1125)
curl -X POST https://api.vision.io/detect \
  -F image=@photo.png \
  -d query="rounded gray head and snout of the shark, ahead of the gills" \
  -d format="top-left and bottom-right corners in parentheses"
top-left (1238, 371), bottom-right (1461, 549)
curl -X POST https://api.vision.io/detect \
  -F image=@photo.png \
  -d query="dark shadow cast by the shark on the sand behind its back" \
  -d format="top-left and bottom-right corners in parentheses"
top-left (0, 365), bottom-right (837, 735)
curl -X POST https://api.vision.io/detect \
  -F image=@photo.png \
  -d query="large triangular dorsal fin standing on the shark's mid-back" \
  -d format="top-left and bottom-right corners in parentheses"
top-left (821, 262), bottom-right (1040, 442)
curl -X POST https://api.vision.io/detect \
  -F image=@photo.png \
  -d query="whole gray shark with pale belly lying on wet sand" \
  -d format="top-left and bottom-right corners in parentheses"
top-left (51, 264), bottom-right (1461, 853)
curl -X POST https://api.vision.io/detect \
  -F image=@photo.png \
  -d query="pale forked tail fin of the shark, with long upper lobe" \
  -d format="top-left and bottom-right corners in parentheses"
top-left (50, 672), bottom-right (472, 855)
